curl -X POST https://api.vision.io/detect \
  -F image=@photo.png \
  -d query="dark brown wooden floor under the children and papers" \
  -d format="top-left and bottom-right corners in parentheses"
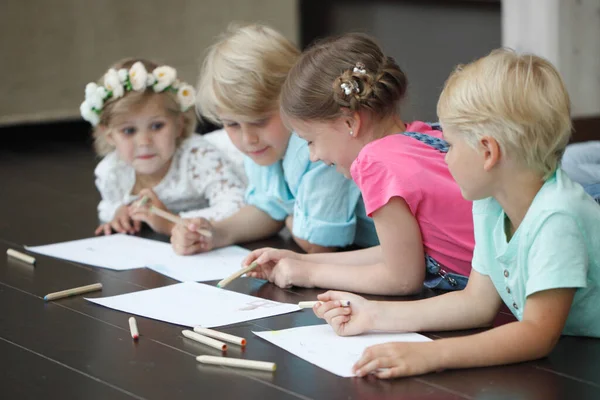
top-left (0, 129), bottom-right (600, 400)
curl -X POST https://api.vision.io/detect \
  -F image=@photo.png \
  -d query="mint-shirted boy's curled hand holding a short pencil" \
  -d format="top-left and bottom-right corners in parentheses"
top-left (313, 290), bottom-right (375, 336)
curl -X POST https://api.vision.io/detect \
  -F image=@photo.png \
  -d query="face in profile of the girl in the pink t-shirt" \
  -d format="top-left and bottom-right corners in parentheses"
top-left (289, 117), bottom-right (359, 179)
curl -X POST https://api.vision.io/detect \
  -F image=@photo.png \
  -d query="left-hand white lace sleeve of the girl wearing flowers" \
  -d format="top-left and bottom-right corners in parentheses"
top-left (94, 153), bottom-right (134, 222)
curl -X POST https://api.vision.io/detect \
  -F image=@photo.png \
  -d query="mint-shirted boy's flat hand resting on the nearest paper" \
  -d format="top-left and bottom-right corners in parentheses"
top-left (352, 342), bottom-right (440, 379)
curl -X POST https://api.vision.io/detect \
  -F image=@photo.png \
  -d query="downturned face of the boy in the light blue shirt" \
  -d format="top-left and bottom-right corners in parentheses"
top-left (219, 111), bottom-right (291, 165)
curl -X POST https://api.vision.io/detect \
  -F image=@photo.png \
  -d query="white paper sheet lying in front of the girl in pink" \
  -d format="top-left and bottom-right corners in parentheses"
top-left (86, 282), bottom-right (300, 328)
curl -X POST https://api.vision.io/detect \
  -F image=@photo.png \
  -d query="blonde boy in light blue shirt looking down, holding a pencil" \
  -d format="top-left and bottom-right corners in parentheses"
top-left (171, 24), bottom-right (378, 254)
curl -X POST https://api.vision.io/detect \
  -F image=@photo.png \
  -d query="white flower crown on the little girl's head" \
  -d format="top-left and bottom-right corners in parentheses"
top-left (79, 61), bottom-right (196, 126)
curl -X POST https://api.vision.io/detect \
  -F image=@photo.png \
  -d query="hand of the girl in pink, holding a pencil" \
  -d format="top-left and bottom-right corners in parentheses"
top-left (246, 258), bottom-right (312, 288)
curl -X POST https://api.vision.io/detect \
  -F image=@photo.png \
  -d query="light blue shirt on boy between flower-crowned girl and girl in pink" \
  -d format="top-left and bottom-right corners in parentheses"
top-left (244, 134), bottom-right (379, 247)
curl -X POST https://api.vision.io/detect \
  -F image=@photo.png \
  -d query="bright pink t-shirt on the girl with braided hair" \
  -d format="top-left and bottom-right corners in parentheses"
top-left (350, 121), bottom-right (475, 276)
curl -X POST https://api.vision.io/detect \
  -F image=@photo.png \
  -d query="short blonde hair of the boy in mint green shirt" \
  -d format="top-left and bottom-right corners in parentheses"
top-left (437, 49), bottom-right (572, 179)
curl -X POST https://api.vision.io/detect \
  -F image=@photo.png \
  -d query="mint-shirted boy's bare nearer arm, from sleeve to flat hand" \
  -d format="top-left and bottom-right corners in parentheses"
top-left (353, 289), bottom-right (575, 378)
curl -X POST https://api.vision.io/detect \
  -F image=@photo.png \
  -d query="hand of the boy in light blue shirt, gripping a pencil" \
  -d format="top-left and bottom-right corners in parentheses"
top-left (171, 218), bottom-right (220, 256)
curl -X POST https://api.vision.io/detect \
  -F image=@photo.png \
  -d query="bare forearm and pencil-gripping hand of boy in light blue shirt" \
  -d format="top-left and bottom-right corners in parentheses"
top-left (171, 206), bottom-right (283, 255)
